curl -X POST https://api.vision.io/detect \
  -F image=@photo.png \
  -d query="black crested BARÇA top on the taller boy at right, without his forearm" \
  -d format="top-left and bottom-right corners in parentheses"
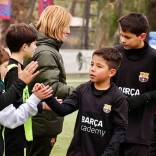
top-left (115, 43), bottom-right (156, 145)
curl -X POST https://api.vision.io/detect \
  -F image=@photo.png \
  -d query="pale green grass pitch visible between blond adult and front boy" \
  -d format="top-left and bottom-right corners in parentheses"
top-left (50, 74), bottom-right (88, 156)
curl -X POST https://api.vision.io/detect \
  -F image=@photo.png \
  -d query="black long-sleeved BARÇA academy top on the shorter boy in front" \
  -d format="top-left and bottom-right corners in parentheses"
top-left (45, 82), bottom-right (128, 156)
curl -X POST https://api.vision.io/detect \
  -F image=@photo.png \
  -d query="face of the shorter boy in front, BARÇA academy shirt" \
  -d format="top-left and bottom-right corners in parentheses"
top-left (89, 55), bottom-right (115, 83)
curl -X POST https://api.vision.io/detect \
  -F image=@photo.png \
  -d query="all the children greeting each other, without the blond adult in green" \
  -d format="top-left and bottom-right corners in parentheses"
top-left (0, 3), bottom-right (156, 156)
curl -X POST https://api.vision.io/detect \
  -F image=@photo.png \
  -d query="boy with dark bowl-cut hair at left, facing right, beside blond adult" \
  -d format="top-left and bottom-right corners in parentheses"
top-left (4, 23), bottom-right (37, 156)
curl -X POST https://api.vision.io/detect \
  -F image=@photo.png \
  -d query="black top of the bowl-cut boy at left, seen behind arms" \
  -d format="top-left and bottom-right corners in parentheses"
top-left (4, 58), bottom-right (26, 154)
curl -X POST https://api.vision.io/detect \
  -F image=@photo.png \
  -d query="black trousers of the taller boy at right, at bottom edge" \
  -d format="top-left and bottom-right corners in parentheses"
top-left (119, 143), bottom-right (149, 156)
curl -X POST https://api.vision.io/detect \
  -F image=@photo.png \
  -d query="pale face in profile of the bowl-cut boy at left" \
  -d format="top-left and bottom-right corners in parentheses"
top-left (23, 41), bottom-right (37, 58)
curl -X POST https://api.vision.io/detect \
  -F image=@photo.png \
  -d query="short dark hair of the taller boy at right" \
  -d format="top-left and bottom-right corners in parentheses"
top-left (118, 12), bottom-right (149, 36)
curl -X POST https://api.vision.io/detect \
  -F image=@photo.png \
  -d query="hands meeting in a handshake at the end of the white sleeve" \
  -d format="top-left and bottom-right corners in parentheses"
top-left (32, 83), bottom-right (53, 100)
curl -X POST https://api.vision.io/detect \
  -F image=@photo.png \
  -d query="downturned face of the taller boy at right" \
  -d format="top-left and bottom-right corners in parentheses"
top-left (120, 26), bottom-right (146, 49)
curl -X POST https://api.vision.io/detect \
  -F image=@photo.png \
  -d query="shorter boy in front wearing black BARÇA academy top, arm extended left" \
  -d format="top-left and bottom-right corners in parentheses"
top-left (45, 48), bottom-right (128, 156)
